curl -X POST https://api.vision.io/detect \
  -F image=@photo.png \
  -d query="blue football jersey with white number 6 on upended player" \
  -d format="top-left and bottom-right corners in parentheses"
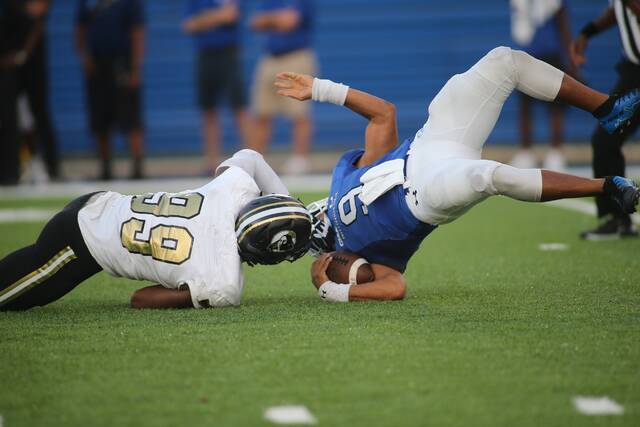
top-left (327, 140), bottom-right (436, 272)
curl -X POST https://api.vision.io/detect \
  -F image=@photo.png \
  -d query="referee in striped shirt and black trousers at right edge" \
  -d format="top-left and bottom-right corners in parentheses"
top-left (571, 0), bottom-right (640, 240)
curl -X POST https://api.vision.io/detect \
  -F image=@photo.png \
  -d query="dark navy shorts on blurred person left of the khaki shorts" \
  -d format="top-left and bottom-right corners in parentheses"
top-left (196, 47), bottom-right (247, 111)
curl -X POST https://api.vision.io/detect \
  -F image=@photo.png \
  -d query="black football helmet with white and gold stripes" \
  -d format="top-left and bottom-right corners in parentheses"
top-left (236, 194), bottom-right (311, 265)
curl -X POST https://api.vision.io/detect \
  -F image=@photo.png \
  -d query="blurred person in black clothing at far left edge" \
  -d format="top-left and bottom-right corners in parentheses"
top-left (0, 0), bottom-right (60, 184)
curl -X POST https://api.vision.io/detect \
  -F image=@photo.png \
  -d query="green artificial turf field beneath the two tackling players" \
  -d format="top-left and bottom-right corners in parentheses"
top-left (0, 195), bottom-right (640, 427)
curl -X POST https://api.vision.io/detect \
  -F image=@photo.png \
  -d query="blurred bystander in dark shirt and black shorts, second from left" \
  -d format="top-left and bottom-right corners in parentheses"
top-left (75, 0), bottom-right (144, 180)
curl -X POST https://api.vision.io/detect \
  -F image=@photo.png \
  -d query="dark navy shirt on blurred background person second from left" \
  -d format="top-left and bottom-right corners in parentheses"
top-left (76, 0), bottom-right (144, 57)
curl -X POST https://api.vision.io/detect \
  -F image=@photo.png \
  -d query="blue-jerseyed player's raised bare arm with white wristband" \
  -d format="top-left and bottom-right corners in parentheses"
top-left (275, 72), bottom-right (398, 167)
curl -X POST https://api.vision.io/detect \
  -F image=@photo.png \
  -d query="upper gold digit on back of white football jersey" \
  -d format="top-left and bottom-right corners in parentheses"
top-left (131, 193), bottom-right (204, 219)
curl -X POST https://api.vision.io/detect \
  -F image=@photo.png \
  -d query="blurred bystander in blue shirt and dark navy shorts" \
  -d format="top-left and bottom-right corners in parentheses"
top-left (182, 0), bottom-right (251, 174)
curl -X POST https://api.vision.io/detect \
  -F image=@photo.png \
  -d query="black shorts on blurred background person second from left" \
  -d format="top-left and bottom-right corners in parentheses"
top-left (87, 58), bottom-right (142, 133)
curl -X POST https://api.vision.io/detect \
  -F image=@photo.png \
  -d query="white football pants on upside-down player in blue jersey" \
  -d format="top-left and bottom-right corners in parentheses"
top-left (405, 47), bottom-right (564, 224)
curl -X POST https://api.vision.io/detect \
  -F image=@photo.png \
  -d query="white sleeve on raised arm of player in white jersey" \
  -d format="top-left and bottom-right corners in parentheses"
top-left (216, 150), bottom-right (289, 195)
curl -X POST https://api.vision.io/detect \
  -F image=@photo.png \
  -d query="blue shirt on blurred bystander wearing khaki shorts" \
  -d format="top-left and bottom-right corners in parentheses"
top-left (259, 0), bottom-right (315, 55)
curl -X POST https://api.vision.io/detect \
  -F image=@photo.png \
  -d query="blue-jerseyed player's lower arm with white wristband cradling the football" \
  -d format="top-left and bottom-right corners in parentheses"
top-left (311, 253), bottom-right (407, 302)
